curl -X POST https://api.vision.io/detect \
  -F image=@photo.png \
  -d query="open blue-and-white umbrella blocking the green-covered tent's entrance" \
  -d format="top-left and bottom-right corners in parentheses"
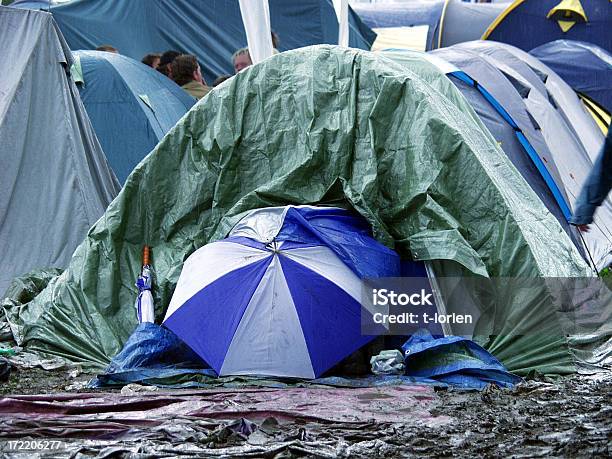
top-left (164, 206), bottom-right (399, 378)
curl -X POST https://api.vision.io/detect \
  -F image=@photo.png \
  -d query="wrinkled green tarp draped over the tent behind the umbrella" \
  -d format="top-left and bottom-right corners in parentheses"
top-left (5, 46), bottom-right (589, 373)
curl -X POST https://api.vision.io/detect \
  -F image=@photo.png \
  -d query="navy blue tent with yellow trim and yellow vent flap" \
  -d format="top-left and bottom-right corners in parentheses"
top-left (482, 0), bottom-right (612, 51)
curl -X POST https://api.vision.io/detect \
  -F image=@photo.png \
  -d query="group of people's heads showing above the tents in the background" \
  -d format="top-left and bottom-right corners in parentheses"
top-left (96, 32), bottom-right (279, 100)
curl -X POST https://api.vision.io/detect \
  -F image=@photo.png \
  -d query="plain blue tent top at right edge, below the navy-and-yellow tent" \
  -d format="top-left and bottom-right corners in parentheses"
top-left (530, 40), bottom-right (612, 111)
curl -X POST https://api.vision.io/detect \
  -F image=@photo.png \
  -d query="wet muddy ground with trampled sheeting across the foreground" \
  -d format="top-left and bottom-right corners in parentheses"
top-left (0, 368), bottom-right (612, 458)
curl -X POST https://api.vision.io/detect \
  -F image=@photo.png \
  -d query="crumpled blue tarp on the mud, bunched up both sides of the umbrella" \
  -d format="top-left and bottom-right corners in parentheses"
top-left (89, 323), bottom-right (521, 389)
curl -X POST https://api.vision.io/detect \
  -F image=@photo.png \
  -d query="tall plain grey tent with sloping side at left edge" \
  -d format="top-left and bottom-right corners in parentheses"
top-left (0, 7), bottom-right (119, 295)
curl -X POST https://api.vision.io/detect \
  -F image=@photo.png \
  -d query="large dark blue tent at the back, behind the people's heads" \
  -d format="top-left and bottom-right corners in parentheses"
top-left (14, 0), bottom-right (376, 83)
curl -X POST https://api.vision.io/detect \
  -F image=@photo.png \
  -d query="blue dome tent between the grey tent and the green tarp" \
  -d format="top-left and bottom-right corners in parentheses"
top-left (72, 51), bottom-right (196, 183)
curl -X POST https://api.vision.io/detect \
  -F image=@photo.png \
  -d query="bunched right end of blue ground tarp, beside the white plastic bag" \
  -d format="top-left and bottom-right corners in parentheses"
top-left (402, 330), bottom-right (521, 389)
